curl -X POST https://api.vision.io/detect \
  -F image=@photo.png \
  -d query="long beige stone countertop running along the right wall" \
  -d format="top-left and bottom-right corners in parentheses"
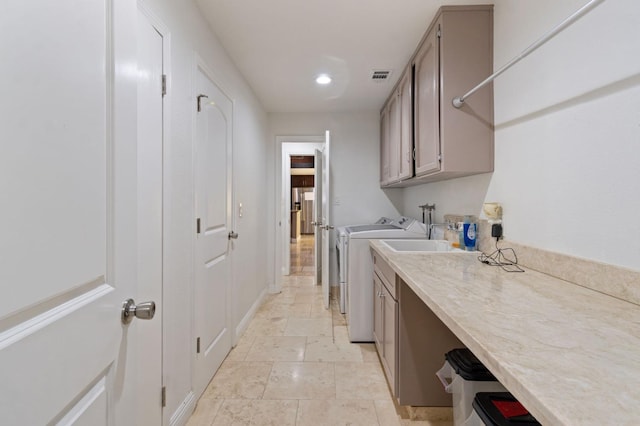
top-left (371, 240), bottom-right (640, 426)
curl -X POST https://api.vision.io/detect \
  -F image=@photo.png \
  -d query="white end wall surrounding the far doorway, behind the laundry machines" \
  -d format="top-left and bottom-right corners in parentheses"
top-left (269, 111), bottom-right (401, 284)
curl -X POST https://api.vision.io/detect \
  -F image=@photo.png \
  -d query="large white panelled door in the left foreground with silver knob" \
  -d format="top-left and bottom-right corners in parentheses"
top-left (0, 0), bottom-right (139, 425)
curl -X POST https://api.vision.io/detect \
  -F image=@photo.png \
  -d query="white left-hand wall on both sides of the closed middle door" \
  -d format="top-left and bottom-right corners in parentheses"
top-left (140, 0), bottom-right (270, 415)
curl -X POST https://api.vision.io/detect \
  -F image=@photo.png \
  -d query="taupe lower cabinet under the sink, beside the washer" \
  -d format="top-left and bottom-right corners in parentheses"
top-left (373, 251), bottom-right (464, 407)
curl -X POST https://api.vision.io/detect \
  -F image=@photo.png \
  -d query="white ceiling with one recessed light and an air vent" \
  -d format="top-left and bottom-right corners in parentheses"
top-left (196, 0), bottom-right (490, 112)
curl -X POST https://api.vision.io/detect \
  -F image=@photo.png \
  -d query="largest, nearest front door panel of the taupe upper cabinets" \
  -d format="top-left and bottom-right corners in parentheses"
top-left (414, 25), bottom-right (440, 176)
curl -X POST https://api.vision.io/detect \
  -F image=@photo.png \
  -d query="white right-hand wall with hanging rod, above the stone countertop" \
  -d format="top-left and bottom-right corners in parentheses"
top-left (403, 0), bottom-right (640, 270)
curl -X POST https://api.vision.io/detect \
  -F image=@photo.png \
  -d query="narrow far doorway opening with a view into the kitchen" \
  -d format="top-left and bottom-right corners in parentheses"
top-left (289, 155), bottom-right (316, 276)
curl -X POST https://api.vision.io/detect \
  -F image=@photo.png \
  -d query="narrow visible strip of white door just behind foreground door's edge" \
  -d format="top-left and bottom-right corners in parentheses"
top-left (135, 10), bottom-right (164, 425)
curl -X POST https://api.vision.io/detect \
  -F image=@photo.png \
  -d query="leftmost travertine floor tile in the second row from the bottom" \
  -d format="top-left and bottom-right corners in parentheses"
top-left (202, 361), bottom-right (273, 399)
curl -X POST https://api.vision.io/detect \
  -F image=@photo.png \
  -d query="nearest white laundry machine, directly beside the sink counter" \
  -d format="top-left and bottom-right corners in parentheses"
top-left (336, 216), bottom-right (427, 342)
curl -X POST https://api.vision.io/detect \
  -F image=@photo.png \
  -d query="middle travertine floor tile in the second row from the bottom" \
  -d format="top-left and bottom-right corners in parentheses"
top-left (264, 362), bottom-right (336, 399)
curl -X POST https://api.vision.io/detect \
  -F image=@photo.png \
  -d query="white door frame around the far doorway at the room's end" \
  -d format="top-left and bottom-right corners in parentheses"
top-left (270, 135), bottom-right (324, 293)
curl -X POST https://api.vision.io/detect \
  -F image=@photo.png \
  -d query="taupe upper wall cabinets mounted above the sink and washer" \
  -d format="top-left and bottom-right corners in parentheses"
top-left (382, 5), bottom-right (494, 187)
